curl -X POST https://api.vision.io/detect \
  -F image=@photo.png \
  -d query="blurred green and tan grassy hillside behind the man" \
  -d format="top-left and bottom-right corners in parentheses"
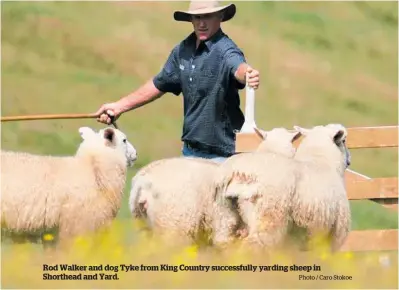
top-left (1, 2), bottom-right (398, 228)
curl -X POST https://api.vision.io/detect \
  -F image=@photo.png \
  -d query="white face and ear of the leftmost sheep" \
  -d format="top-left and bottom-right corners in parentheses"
top-left (79, 127), bottom-right (137, 167)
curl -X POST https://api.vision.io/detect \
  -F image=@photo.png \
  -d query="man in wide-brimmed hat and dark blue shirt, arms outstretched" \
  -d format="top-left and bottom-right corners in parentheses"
top-left (97, 1), bottom-right (259, 161)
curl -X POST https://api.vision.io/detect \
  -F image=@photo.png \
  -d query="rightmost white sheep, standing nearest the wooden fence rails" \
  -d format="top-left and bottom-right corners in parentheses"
top-left (292, 124), bottom-right (351, 251)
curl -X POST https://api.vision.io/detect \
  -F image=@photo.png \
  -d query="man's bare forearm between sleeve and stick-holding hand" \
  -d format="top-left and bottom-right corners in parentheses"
top-left (118, 79), bottom-right (164, 112)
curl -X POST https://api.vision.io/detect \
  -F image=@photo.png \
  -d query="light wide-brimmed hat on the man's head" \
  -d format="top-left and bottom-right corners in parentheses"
top-left (173, 1), bottom-right (236, 22)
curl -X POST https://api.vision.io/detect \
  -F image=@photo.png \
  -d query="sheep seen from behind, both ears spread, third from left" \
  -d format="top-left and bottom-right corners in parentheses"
top-left (215, 128), bottom-right (301, 247)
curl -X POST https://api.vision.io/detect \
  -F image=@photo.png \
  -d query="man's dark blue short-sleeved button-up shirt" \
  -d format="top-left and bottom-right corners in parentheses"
top-left (154, 29), bottom-right (246, 156)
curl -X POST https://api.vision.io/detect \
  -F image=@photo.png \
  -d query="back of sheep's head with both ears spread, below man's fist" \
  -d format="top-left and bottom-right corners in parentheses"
top-left (254, 128), bottom-right (302, 157)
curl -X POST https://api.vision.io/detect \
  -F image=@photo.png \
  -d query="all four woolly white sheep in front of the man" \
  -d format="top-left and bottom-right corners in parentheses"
top-left (1, 124), bottom-right (351, 251)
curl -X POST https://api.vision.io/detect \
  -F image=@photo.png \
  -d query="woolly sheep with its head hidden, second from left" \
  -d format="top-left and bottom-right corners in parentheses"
top-left (129, 157), bottom-right (245, 245)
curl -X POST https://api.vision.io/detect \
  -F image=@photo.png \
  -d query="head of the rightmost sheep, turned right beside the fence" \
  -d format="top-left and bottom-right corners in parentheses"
top-left (294, 124), bottom-right (351, 172)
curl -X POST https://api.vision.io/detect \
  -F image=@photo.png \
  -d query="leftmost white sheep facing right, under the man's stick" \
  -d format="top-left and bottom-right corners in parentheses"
top-left (1, 127), bottom-right (137, 245)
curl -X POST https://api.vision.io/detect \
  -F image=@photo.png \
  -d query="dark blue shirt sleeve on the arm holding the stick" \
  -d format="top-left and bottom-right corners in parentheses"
top-left (153, 45), bottom-right (182, 96)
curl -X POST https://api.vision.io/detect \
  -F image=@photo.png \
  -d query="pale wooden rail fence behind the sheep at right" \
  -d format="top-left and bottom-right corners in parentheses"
top-left (236, 126), bottom-right (399, 251)
